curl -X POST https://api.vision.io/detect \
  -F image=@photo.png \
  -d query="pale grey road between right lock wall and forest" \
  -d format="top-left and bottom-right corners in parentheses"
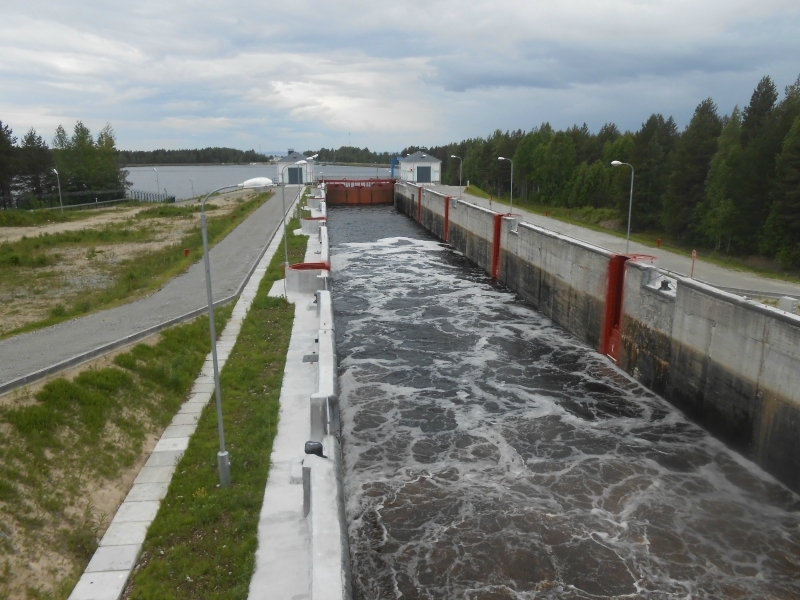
top-left (432, 185), bottom-right (800, 298)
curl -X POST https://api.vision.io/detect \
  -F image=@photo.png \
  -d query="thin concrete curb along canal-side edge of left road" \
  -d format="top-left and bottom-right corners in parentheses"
top-left (0, 193), bottom-right (288, 396)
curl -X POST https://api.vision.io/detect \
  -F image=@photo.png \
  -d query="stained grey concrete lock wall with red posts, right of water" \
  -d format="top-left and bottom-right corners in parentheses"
top-left (395, 182), bottom-right (800, 490)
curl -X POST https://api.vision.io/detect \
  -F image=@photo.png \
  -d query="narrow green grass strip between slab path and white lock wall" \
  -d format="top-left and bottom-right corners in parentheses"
top-left (126, 203), bottom-right (307, 599)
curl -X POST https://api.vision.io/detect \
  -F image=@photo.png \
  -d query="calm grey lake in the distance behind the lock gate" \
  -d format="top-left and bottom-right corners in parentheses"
top-left (127, 165), bottom-right (389, 200)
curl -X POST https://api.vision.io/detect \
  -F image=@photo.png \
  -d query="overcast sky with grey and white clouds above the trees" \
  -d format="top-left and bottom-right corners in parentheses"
top-left (0, 0), bottom-right (800, 151)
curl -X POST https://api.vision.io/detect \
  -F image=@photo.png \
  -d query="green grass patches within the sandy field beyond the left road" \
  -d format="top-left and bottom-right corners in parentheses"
top-left (0, 192), bottom-right (272, 339)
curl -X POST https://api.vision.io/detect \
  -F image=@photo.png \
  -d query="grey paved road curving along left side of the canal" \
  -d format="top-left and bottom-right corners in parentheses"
top-left (0, 186), bottom-right (298, 392)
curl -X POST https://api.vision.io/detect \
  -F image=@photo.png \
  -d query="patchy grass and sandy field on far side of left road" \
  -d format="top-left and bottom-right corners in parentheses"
top-left (0, 192), bottom-right (271, 338)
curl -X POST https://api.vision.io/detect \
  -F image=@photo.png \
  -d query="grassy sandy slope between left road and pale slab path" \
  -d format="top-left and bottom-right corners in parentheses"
top-left (0, 306), bottom-right (233, 598)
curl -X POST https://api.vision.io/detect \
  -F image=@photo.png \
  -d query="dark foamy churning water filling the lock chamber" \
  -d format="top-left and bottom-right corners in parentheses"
top-left (329, 207), bottom-right (800, 599)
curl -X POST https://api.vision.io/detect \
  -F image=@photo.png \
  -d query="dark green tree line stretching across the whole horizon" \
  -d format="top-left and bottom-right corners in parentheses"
top-left (0, 76), bottom-right (800, 267)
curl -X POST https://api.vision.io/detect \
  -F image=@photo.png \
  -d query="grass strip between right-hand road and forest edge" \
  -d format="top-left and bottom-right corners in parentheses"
top-left (464, 185), bottom-right (800, 283)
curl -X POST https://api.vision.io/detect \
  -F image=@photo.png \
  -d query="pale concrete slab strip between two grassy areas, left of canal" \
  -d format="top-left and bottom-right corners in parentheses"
top-left (69, 190), bottom-right (302, 600)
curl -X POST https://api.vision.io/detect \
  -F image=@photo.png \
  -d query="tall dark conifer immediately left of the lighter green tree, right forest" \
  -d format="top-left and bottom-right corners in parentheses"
top-left (662, 98), bottom-right (722, 238)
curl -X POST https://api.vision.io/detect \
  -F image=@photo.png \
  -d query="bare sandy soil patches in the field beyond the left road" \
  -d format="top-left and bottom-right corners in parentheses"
top-left (0, 197), bottom-right (251, 335)
